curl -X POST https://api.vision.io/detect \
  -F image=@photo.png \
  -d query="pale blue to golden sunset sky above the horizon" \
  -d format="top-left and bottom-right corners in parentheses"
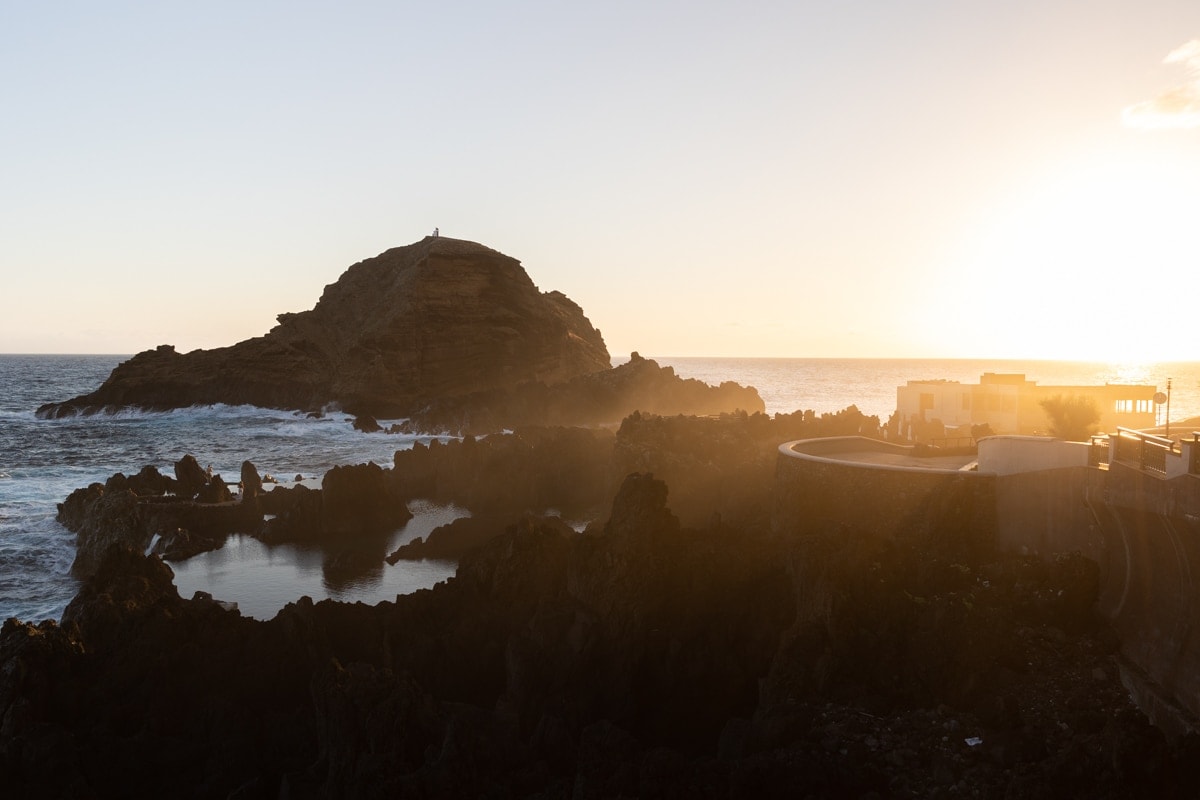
top-left (0, 0), bottom-right (1200, 361)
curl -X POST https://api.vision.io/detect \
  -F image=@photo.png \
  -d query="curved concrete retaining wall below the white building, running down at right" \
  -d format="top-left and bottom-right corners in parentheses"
top-left (775, 437), bottom-right (1200, 735)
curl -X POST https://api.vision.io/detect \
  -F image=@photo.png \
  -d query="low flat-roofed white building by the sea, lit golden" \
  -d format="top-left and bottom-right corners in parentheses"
top-left (888, 372), bottom-right (1158, 441)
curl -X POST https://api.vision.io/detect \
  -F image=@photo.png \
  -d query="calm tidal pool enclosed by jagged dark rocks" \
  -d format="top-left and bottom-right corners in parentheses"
top-left (169, 500), bottom-right (470, 619)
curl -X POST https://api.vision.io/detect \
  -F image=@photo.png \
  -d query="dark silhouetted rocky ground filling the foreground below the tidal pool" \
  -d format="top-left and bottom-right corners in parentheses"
top-left (0, 474), bottom-right (1200, 800)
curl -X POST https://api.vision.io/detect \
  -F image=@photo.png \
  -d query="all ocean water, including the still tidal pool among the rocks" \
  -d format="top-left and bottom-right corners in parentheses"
top-left (0, 355), bottom-right (1200, 620)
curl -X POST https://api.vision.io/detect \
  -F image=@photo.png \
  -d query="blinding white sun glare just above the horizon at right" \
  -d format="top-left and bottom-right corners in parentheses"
top-left (940, 146), bottom-right (1200, 361)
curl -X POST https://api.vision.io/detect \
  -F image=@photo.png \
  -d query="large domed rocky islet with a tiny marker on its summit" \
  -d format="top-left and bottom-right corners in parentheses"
top-left (38, 236), bottom-right (610, 416)
